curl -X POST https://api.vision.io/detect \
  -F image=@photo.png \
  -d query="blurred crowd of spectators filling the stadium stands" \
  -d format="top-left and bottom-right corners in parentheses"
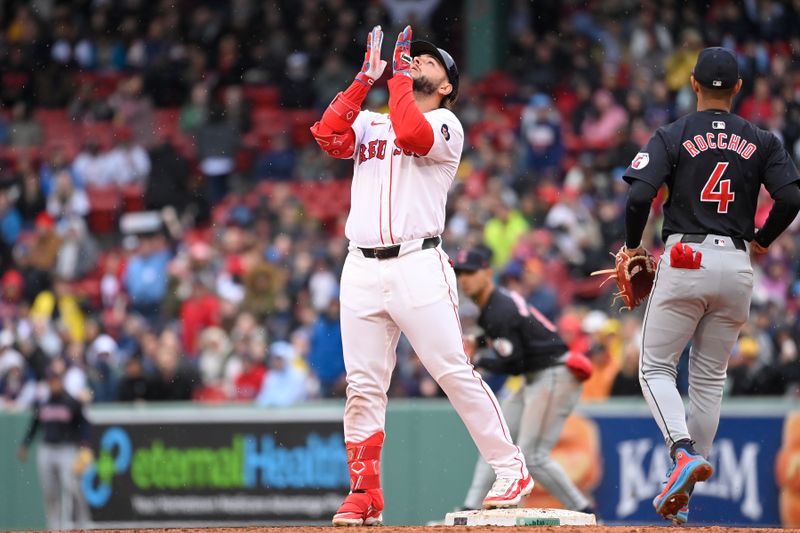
top-left (0, 0), bottom-right (800, 408)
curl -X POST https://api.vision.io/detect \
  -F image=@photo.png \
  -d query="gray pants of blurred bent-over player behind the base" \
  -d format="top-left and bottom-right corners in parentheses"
top-left (464, 365), bottom-right (589, 510)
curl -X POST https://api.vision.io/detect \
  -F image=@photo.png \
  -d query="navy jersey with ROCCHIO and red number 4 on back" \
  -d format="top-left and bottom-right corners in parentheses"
top-left (624, 109), bottom-right (800, 241)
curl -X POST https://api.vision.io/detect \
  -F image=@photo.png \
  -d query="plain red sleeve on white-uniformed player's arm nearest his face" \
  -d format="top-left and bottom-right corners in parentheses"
top-left (389, 76), bottom-right (433, 155)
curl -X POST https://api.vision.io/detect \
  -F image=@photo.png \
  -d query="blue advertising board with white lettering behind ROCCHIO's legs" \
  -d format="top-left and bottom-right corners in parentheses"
top-left (592, 413), bottom-right (784, 526)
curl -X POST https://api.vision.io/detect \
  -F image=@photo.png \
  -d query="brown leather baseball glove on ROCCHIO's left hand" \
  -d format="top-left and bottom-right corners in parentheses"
top-left (592, 246), bottom-right (656, 310)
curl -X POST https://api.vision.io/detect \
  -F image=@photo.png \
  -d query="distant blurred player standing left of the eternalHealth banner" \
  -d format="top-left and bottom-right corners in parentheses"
top-left (17, 365), bottom-right (91, 530)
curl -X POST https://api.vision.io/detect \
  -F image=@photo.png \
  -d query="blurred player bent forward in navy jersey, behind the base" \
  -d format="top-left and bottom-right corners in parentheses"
top-left (454, 246), bottom-right (593, 513)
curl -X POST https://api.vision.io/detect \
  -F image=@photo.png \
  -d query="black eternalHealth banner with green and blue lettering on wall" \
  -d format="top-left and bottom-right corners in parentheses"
top-left (81, 410), bottom-right (349, 527)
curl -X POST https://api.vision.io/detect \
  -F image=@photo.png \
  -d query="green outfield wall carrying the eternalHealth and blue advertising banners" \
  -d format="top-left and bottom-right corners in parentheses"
top-left (0, 399), bottom-right (800, 530)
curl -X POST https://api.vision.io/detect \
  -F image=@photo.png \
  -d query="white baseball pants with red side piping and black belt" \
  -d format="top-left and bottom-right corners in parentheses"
top-left (340, 246), bottom-right (528, 478)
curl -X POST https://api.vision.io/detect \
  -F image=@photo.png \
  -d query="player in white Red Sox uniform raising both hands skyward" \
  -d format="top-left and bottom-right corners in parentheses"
top-left (311, 26), bottom-right (533, 526)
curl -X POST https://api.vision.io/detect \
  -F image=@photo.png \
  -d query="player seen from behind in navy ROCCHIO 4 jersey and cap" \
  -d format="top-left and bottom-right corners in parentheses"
top-left (625, 48), bottom-right (800, 523)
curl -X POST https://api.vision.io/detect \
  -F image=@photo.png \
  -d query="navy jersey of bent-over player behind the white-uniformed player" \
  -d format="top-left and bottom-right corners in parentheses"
top-left (478, 287), bottom-right (567, 374)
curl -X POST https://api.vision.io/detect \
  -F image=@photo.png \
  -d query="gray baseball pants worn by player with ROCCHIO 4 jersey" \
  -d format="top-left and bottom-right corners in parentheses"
top-left (639, 234), bottom-right (753, 457)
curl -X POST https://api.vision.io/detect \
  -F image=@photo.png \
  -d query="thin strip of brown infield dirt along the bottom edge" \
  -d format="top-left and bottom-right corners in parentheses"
top-left (48, 523), bottom-right (800, 533)
